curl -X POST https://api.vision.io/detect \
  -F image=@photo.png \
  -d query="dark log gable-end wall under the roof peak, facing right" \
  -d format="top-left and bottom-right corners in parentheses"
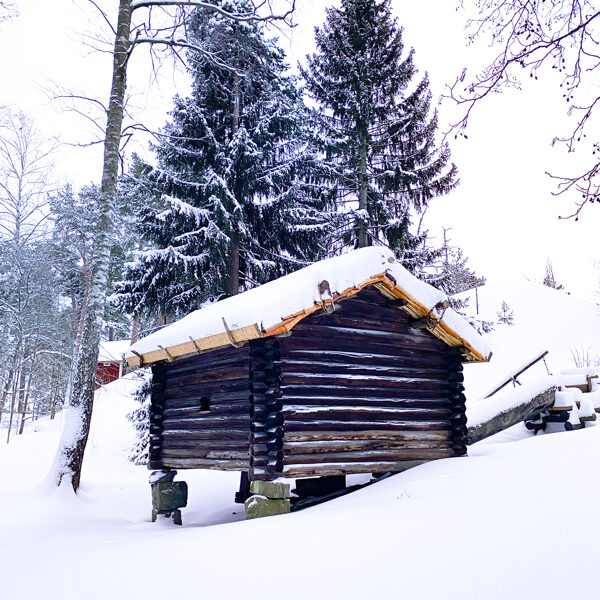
top-left (251, 288), bottom-right (467, 479)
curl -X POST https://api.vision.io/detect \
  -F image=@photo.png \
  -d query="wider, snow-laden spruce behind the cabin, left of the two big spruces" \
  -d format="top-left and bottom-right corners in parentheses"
top-left (117, 0), bottom-right (331, 322)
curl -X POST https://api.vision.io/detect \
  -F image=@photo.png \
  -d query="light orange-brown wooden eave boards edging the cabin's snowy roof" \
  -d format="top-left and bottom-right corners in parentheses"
top-left (127, 273), bottom-right (486, 367)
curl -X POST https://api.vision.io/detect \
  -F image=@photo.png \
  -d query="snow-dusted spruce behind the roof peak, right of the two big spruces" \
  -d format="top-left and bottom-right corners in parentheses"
top-left (301, 0), bottom-right (456, 268)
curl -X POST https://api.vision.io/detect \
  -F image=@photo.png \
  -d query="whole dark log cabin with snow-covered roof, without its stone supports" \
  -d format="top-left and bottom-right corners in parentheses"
top-left (127, 247), bottom-right (490, 488)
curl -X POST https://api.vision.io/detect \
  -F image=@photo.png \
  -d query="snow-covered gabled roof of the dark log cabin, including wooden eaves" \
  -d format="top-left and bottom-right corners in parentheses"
top-left (126, 247), bottom-right (490, 366)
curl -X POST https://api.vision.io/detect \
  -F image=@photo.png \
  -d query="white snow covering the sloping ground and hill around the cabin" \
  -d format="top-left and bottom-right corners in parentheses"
top-left (0, 278), bottom-right (600, 600)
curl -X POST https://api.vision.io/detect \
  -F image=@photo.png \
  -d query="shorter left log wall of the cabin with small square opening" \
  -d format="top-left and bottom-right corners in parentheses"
top-left (149, 346), bottom-right (250, 471)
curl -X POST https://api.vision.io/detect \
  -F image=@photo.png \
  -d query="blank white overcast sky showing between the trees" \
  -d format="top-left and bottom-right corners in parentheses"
top-left (0, 0), bottom-right (600, 296)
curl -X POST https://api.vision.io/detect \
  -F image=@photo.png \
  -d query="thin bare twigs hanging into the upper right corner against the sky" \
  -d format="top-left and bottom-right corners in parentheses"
top-left (445, 0), bottom-right (600, 219)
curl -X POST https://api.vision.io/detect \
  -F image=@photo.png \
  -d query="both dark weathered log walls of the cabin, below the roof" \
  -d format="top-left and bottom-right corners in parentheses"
top-left (152, 289), bottom-right (466, 479)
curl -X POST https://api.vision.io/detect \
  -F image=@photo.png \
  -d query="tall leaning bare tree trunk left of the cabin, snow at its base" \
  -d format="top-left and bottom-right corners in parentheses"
top-left (51, 0), bottom-right (132, 491)
